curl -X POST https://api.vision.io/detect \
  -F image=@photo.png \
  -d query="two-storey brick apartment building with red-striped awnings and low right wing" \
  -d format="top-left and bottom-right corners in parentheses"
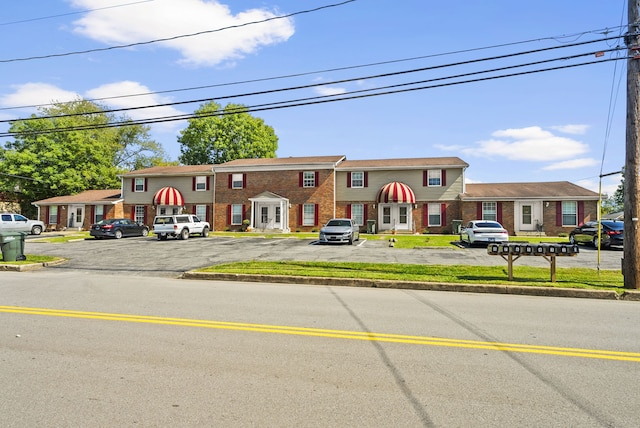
top-left (114, 156), bottom-right (598, 235)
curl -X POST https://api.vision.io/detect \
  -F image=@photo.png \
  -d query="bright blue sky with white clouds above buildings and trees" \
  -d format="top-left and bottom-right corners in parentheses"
top-left (0, 0), bottom-right (627, 195)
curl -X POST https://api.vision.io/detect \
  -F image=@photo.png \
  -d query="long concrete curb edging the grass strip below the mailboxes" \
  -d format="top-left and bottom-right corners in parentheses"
top-left (182, 271), bottom-right (640, 301)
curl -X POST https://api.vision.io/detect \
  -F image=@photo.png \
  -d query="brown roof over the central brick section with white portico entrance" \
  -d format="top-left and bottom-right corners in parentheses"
top-left (213, 155), bottom-right (345, 173)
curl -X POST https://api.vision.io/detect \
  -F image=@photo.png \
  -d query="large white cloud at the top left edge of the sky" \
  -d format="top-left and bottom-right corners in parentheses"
top-left (72, 0), bottom-right (294, 66)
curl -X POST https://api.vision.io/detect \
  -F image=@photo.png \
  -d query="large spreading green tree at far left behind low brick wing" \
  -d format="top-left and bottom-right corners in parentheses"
top-left (0, 100), bottom-right (170, 213)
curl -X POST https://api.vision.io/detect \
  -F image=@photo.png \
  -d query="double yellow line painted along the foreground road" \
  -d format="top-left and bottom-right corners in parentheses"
top-left (5, 306), bottom-right (640, 362)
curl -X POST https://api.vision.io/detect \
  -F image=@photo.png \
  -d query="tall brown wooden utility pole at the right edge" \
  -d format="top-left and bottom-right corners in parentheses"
top-left (623, 0), bottom-right (640, 289)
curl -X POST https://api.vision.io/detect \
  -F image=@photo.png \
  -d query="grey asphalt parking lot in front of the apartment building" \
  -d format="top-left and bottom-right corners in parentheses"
top-left (25, 236), bottom-right (623, 277)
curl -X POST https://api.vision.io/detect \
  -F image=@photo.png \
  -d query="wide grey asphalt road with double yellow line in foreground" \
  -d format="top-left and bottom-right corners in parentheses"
top-left (0, 272), bottom-right (640, 427)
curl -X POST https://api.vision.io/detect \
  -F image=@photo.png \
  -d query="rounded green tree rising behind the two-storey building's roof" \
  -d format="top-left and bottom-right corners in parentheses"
top-left (178, 101), bottom-right (278, 165)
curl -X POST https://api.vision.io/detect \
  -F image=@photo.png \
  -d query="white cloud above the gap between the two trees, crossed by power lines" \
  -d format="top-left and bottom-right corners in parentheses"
top-left (86, 81), bottom-right (184, 130)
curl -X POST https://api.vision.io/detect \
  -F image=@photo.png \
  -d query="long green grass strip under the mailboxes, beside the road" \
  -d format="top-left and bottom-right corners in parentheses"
top-left (198, 261), bottom-right (624, 291)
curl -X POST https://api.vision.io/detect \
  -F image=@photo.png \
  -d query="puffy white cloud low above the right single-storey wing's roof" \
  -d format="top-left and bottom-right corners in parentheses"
top-left (462, 126), bottom-right (589, 162)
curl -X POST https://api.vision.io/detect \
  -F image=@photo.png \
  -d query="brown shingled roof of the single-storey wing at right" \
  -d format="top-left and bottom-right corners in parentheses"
top-left (460, 181), bottom-right (598, 201)
